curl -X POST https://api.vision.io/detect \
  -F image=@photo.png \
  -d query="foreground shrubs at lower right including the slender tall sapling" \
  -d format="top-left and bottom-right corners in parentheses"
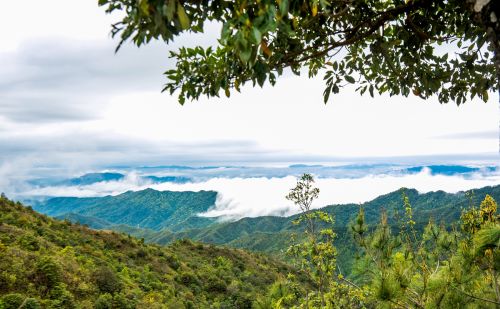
top-left (254, 174), bottom-right (500, 308)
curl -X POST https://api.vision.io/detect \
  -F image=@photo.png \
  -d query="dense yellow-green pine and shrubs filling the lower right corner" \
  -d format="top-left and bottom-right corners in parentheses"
top-left (344, 195), bottom-right (500, 308)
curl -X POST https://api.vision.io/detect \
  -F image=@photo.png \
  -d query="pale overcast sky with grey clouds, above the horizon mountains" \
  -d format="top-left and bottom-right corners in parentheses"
top-left (0, 0), bottom-right (499, 180)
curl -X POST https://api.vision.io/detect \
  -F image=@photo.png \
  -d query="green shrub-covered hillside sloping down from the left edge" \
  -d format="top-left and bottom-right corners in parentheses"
top-left (0, 196), bottom-right (307, 309)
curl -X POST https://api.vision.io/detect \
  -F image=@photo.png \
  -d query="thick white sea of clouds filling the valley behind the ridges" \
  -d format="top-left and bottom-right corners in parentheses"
top-left (18, 168), bottom-right (500, 220)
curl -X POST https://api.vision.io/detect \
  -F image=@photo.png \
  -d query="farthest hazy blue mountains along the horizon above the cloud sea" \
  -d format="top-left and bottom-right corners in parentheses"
top-left (28, 163), bottom-right (499, 187)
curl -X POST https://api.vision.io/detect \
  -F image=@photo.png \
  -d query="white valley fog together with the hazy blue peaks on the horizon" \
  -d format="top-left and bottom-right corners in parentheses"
top-left (6, 163), bottom-right (500, 220)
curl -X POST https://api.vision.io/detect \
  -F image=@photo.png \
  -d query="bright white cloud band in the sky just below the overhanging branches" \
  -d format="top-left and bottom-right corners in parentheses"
top-left (98, 76), bottom-right (498, 157)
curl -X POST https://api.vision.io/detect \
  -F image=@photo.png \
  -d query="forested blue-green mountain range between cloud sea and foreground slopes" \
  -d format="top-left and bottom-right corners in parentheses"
top-left (35, 185), bottom-right (500, 270)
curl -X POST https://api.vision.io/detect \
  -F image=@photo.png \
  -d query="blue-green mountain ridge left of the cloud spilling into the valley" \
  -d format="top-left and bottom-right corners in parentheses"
top-left (34, 189), bottom-right (217, 231)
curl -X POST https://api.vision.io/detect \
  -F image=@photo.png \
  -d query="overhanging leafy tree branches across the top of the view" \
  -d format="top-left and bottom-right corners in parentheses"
top-left (99, 0), bottom-right (500, 104)
